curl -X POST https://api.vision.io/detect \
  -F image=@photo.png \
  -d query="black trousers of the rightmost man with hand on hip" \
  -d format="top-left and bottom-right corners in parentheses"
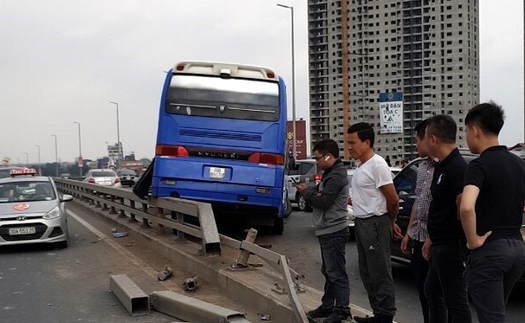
top-left (467, 238), bottom-right (525, 323)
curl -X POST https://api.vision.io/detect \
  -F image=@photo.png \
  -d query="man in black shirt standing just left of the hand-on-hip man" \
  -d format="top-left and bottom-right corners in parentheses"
top-left (422, 115), bottom-right (472, 323)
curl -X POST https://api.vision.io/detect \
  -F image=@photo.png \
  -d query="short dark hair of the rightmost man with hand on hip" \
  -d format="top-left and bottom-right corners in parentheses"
top-left (465, 101), bottom-right (505, 136)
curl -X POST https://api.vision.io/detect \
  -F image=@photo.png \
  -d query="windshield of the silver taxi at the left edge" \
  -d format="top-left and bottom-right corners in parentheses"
top-left (0, 181), bottom-right (56, 203)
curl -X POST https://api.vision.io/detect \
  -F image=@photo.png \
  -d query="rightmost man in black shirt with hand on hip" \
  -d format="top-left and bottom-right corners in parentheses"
top-left (460, 102), bottom-right (525, 323)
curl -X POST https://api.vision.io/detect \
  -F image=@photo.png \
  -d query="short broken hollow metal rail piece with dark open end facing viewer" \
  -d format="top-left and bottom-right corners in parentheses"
top-left (109, 275), bottom-right (150, 316)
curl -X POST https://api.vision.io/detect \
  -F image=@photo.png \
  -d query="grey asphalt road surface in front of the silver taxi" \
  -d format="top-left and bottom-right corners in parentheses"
top-left (0, 210), bottom-right (175, 323)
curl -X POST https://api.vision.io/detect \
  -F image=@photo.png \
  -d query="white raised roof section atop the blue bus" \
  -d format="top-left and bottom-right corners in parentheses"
top-left (173, 62), bottom-right (279, 81)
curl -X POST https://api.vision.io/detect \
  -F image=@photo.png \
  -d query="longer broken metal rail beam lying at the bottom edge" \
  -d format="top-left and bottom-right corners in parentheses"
top-left (150, 291), bottom-right (250, 323)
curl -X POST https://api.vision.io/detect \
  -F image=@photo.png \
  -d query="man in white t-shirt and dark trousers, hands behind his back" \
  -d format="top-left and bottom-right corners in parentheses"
top-left (346, 122), bottom-right (403, 323)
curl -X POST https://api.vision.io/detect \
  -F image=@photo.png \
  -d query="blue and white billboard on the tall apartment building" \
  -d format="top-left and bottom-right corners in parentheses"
top-left (379, 92), bottom-right (403, 133)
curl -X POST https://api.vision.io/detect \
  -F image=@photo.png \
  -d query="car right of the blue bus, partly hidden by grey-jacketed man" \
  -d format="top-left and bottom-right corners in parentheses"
top-left (285, 159), bottom-right (321, 211)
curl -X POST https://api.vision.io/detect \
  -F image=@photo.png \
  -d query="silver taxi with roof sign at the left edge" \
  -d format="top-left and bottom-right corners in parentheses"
top-left (0, 169), bottom-right (73, 248)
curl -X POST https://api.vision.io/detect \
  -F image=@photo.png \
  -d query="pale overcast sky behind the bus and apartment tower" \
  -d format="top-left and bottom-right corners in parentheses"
top-left (0, 0), bottom-right (524, 163)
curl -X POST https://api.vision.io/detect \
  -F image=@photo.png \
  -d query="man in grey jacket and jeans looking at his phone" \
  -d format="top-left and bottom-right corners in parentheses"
top-left (297, 139), bottom-right (352, 323)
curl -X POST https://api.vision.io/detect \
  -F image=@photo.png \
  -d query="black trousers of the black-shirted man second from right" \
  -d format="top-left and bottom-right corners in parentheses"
top-left (425, 239), bottom-right (472, 323)
